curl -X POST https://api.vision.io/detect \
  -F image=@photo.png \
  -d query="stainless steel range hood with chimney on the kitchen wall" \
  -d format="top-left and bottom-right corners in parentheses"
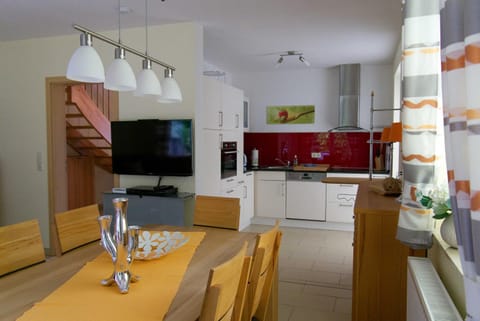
top-left (330, 64), bottom-right (365, 131)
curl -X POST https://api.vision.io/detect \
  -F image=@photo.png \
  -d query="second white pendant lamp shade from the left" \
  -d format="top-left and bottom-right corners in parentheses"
top-left (103, 48), bottom-right (137, 91)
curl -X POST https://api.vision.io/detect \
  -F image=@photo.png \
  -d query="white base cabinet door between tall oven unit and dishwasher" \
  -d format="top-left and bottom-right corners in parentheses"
top-left (255, 171), bottom-right (286, 218)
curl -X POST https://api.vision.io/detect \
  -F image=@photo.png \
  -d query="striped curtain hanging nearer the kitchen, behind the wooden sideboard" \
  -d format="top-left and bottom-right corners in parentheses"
top-left (397, 0), bottom-right (445, 249)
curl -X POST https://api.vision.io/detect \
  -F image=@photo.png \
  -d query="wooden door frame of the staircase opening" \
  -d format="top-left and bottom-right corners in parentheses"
top-left (45, 77), bottom-right (119, 255)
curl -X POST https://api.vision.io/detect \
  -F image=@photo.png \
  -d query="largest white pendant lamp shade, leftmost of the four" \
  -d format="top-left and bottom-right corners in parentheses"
top-left (67, 33), bottom-right (105, 83)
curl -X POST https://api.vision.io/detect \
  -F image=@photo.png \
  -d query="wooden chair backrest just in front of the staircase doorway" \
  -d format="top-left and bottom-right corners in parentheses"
top-left (55, 204), bottom-right (100, 253)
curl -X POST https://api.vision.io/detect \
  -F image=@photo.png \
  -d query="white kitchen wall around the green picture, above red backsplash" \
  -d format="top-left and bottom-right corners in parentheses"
top-left (232, 65), bottom-right (393, 132)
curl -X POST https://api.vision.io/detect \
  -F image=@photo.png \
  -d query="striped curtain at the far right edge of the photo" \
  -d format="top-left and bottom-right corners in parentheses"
top-left (441, 0), bottom-right (480, 321)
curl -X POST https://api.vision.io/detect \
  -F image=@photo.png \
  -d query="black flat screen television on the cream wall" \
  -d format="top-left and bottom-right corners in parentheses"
top-left (111, 119), bottom-right (193, 176)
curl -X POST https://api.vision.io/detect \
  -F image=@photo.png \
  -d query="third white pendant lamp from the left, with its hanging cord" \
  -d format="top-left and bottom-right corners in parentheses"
top-left (134, 0), bottom-right (162, 96)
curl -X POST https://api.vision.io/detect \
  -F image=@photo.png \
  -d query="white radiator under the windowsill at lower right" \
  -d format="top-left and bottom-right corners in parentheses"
top-left (407, 257), bottom-right (462, 321)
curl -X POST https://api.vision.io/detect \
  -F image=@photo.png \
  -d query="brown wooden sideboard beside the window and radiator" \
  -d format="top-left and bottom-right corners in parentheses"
top-left (352, 181), bottom-right (425, 321)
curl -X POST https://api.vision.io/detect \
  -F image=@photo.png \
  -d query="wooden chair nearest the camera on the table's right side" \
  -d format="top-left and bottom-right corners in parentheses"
top-left (199, 242), bottom-right (251, 321)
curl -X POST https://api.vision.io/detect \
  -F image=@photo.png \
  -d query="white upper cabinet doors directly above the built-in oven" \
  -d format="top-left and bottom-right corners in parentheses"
top-left (200, 76), bottom-right (243, 131)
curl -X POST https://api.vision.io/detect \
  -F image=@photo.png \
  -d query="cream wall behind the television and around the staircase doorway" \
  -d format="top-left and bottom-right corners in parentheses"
top-left (0, 23), bottom-right (203, 245)
